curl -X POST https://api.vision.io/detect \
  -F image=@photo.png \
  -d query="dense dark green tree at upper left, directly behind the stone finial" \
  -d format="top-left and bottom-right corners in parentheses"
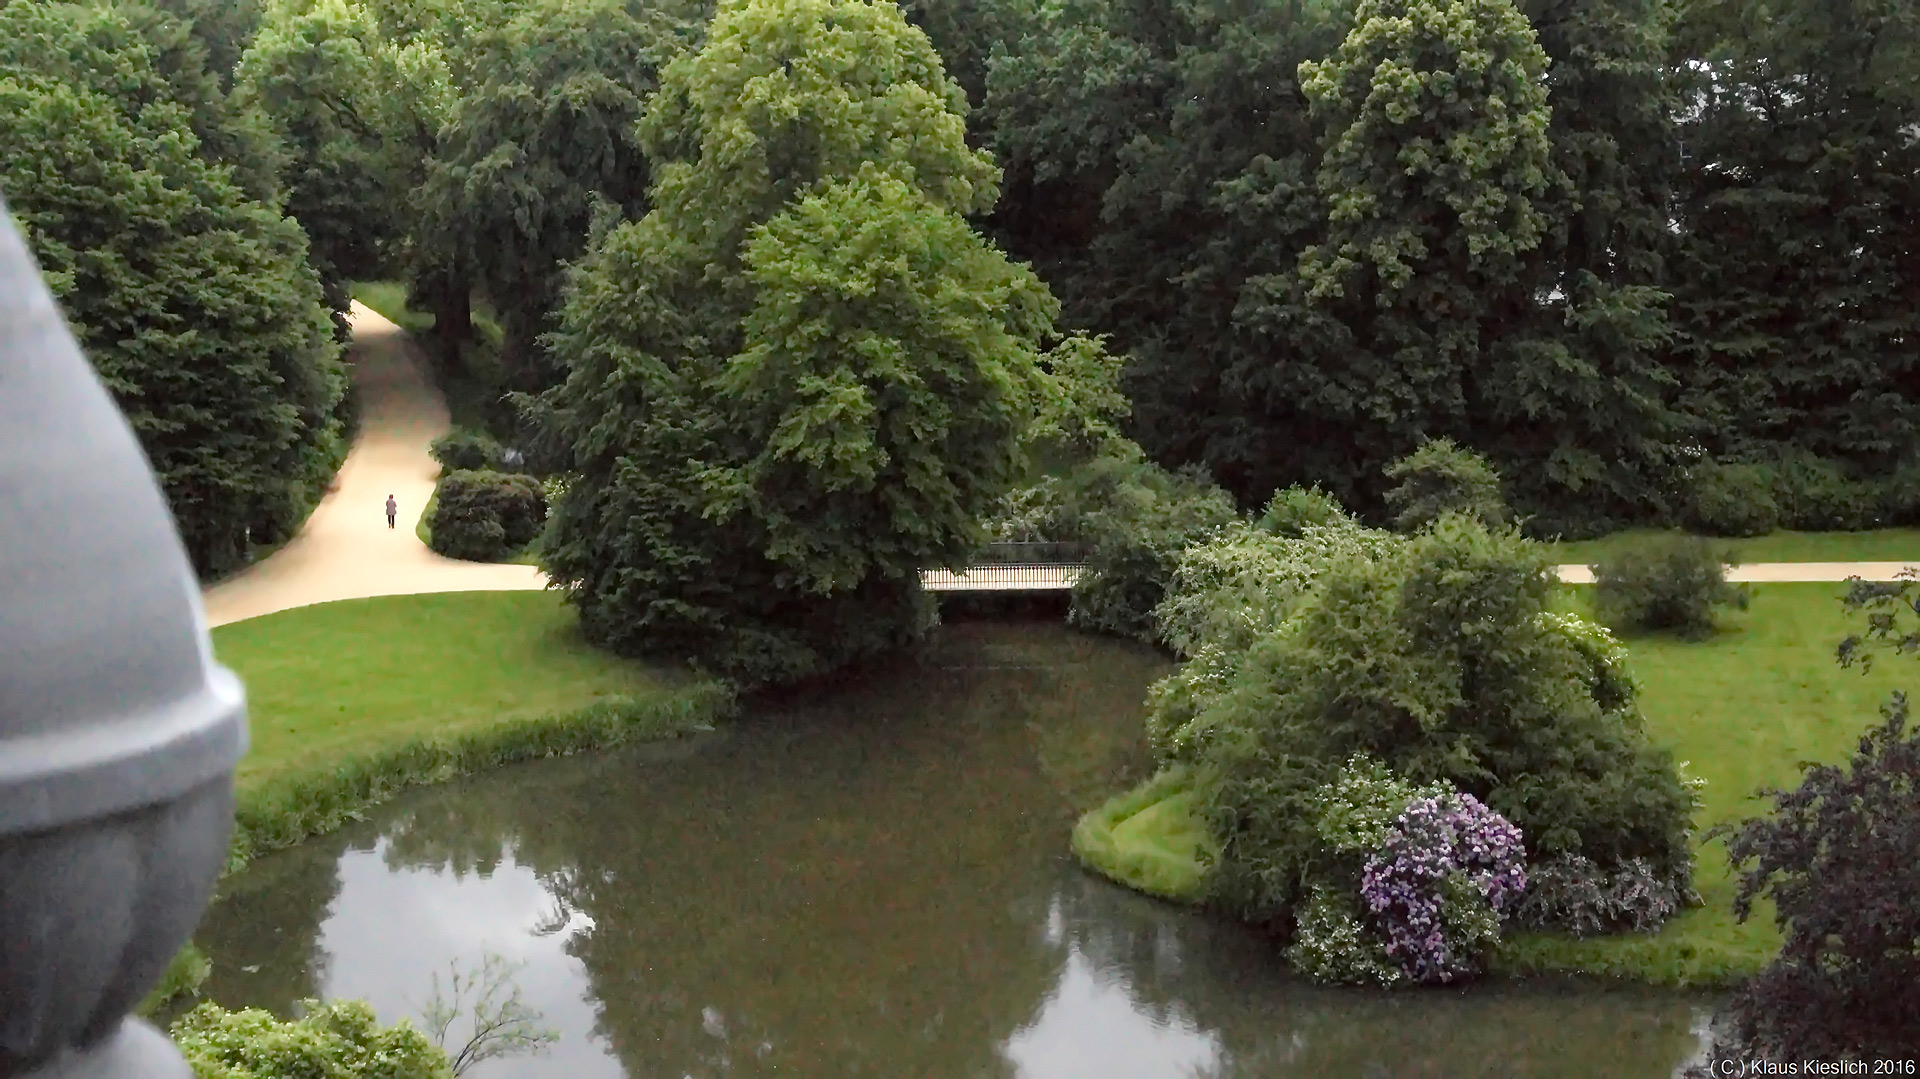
top-left (0, 0), bottom-right (346, 576)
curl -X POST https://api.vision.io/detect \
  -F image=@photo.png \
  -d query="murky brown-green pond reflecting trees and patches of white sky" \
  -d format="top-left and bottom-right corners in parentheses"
top-left (196, 622), bottom-right (1709, 1079)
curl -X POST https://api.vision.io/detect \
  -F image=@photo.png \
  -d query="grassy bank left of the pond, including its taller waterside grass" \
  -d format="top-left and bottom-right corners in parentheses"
top-left (144, 591), bottom-right (733, 1010)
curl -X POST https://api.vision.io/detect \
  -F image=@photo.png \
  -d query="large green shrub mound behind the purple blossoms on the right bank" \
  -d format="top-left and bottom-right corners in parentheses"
top-left (1182, 515), bottom-right (1695, 922)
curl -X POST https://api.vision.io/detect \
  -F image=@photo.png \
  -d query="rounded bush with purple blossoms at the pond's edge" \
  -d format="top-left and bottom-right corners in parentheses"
top-left (1359, 793), bottom-right (1526, 983)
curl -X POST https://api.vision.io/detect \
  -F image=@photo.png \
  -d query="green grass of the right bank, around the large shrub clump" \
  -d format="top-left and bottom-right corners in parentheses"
top-left (1075, 584), bottom-right (1920, 985)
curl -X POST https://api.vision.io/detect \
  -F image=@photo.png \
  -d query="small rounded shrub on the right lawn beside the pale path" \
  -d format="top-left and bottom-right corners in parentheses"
top-left (1594, 536), bottom-right (1747, 637)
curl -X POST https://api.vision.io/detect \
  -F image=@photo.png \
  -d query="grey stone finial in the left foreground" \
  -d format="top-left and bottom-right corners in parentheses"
top-left (0, 202), bottom-right (246, 1079)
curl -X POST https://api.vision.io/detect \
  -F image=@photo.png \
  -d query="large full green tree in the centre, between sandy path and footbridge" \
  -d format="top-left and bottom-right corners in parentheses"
top-left (532, 0), bottom-right (1077, 683)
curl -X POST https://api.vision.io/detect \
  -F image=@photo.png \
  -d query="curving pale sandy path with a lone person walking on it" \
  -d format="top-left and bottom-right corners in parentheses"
top-left (204, 303), bottom-right (547, 626)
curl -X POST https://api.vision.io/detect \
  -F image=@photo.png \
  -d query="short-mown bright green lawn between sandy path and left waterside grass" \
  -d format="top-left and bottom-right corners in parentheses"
top-left (213, 591), bottom-right (687, 779)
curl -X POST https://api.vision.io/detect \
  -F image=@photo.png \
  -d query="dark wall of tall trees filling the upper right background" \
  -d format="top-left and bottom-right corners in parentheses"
top-left (968, 0), bottom-right (1920, 534)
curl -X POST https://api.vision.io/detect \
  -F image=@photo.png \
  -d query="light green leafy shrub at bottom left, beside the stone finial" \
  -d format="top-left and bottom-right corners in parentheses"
top-left (173, 1000), bottom-right (453, 1079)
